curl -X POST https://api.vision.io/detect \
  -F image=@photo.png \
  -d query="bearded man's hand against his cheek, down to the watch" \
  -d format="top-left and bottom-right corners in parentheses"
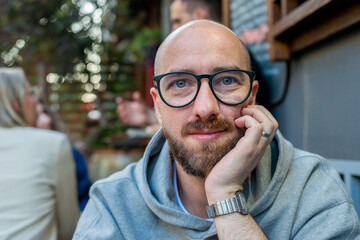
top-left (205, 105), bottom-right (278, 204)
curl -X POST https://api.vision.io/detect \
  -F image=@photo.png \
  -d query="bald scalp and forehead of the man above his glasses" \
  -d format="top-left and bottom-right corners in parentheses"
top-left (155, 20), bottom-right (251, 75)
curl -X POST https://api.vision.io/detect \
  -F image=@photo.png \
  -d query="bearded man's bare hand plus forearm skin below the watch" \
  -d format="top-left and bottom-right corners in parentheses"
top-left (205, 105), bottom-right (278, 239)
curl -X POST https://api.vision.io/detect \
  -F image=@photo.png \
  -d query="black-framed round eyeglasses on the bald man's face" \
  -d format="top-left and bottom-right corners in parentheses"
top-left (153, 69), bottom-right (255, 108)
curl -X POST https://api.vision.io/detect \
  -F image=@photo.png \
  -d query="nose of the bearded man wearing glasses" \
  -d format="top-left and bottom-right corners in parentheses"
top-left (193, 79), bottom-right (219, 120)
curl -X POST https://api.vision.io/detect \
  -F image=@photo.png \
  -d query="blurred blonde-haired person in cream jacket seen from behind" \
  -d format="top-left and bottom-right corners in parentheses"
top-left (0, 68), bottom-right (80, 240)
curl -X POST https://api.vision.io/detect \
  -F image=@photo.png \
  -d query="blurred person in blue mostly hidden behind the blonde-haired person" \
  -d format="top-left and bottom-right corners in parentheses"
top-left (36, 101), bottom-right (91, 211)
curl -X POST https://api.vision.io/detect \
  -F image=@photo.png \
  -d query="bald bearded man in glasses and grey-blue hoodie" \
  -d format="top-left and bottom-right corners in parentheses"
top-left (74, 20), bottom-right (360, 239)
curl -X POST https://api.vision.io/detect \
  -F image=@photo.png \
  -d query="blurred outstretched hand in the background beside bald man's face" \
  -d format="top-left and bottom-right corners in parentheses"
top-left (116, 91), bottom-right (149, 127)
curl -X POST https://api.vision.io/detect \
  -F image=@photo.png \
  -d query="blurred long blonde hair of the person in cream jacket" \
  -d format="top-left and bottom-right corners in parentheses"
top-left (0, 68), bottom-right (29, 127)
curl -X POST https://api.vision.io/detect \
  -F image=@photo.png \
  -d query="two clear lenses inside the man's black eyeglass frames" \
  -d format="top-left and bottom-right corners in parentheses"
top-left (159, 71), bottom-right (251, 107)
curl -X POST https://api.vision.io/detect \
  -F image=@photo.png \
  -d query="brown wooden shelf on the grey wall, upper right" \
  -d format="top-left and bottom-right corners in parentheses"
top-left (266, 0), bottom-right (360, 61)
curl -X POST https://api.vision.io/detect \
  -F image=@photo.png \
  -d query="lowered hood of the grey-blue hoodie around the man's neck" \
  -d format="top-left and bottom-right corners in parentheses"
top-left (136, 129), bottom-right (292, 233)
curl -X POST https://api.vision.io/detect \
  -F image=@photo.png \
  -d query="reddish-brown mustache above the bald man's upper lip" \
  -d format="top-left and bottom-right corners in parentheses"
top-left (181, 119), bottom-right (235, 136)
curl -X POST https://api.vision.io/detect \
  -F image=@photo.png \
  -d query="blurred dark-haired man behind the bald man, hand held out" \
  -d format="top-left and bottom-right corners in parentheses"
top-left (116, 0), bottom-right (270, 133)
